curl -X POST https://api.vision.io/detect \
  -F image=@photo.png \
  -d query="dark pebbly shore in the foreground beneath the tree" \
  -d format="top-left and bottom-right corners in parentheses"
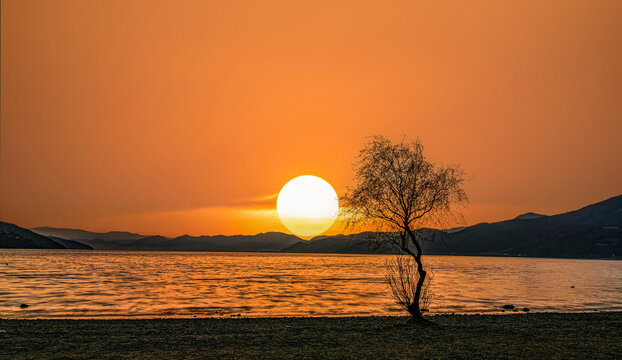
top-left (0, 312), bottom-right (622, 359)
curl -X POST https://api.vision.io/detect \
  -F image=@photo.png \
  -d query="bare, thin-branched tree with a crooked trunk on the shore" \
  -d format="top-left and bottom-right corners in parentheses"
top-left (342, 136), bottom-right (468, 321)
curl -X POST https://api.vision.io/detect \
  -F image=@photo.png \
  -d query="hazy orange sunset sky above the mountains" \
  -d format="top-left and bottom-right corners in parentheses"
top-left (0, 0), bottom-right (622, 235)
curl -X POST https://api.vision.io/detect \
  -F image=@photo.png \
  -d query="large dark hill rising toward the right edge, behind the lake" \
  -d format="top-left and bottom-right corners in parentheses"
top-left (426, 195), bottom-right (622, 258)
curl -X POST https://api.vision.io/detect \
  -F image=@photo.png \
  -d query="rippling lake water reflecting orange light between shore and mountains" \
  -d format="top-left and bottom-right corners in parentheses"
top-left (0, 250), bottom-right (622, 318)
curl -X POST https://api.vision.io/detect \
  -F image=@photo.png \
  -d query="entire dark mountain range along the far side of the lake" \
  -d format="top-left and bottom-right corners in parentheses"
top-left (0, 195), bottom-right (622, 258)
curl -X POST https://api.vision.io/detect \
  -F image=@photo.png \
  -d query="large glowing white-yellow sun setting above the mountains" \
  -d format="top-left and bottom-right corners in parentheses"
top-left (276, 175), bottom-right (339, 236)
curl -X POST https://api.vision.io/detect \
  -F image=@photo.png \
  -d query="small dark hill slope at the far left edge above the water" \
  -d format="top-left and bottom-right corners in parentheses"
top-left (0, 222), bottom-right (93, 249)
